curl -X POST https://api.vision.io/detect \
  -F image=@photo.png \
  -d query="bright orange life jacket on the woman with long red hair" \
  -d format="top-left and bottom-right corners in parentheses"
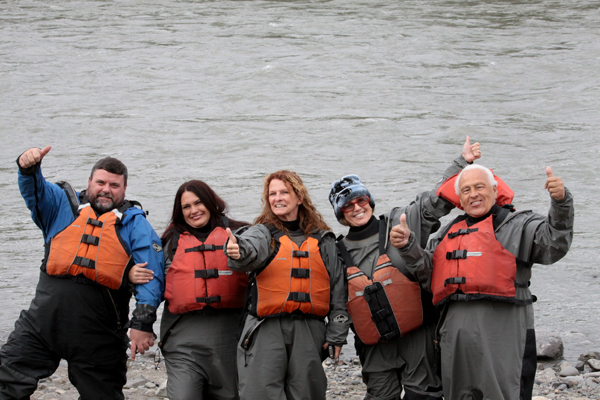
top-left (250, 229), bottom-right (330, 317)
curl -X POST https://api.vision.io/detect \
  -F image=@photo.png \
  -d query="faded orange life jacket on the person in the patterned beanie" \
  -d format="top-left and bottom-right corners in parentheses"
top-left (337, 217), bottom-right (423, 345)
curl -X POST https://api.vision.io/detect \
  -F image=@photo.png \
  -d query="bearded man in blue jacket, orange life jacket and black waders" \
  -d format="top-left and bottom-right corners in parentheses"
top-left (0, 146), bottom-right (164, 400)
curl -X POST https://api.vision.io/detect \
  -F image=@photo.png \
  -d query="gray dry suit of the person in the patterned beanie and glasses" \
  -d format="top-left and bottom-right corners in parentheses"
top-left (343, 156), bottom-right (467, 400)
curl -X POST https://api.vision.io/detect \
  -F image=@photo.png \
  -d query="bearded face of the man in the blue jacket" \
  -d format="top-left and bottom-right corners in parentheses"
top-left (86, 169), bottom-right (127, 214)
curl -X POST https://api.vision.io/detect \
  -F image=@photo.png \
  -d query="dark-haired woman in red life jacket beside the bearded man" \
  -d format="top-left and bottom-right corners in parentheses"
top-left (129, 180), bottom-right (248, 400)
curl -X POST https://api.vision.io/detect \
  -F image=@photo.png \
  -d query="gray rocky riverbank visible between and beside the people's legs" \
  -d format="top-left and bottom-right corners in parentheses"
top-left (31, 337), bottom-right (600, 400)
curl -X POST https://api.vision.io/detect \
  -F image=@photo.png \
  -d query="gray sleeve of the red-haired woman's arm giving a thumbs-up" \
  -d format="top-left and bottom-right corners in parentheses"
top-left (223, 225), bottom-right (271, 272)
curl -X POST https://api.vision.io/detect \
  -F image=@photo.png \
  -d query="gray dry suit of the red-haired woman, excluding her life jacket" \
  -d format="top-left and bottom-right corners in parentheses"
top-left (225, 225), bottom-right (350, 400)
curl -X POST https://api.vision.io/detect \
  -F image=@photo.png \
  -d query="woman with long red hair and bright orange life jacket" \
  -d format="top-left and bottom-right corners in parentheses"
top-left (226, 171), bottom-right (349, 400)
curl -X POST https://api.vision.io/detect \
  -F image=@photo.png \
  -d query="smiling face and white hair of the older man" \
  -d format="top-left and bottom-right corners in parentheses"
top-left (458, 169), bottom-right (498, 218)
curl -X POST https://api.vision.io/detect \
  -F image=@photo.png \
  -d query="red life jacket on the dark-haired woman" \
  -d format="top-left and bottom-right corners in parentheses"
top-left (165, 227), bottom-right (248, 314)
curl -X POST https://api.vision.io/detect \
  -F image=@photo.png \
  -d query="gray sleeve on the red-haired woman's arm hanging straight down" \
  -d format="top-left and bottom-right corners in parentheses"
top-left (320, 233), bottom-right (350, 347)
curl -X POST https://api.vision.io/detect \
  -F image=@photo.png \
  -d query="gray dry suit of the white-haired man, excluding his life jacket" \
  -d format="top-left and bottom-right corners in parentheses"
top-left (401, 189), bottom-right (574, 400)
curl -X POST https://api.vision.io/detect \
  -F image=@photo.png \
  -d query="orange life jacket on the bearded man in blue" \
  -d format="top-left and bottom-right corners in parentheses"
top-left (45, 203), bottom-right (131, 290)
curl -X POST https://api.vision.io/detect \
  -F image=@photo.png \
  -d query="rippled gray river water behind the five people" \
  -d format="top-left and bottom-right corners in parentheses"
top-left (0, 0), bottom-right (600, 361)
